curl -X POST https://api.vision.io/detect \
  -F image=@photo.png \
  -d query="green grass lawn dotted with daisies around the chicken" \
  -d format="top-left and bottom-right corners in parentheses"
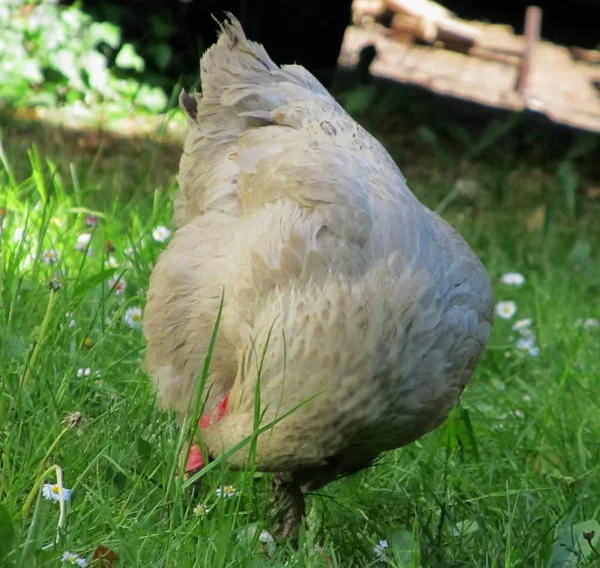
top-left (0, 104), bottom-right (600, 568)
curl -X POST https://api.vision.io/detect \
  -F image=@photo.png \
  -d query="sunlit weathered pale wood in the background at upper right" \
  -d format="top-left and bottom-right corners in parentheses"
top-left (339, 23), bottom-right (600, 132)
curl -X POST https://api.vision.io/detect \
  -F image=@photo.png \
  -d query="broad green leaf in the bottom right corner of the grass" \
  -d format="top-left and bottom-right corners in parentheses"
top-left (548, 519), bottom-right (600, 568)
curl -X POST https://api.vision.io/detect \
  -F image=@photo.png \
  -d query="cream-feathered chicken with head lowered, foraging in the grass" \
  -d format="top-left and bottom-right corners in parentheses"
top-left (144, 15), bottom-right (493, 536)
